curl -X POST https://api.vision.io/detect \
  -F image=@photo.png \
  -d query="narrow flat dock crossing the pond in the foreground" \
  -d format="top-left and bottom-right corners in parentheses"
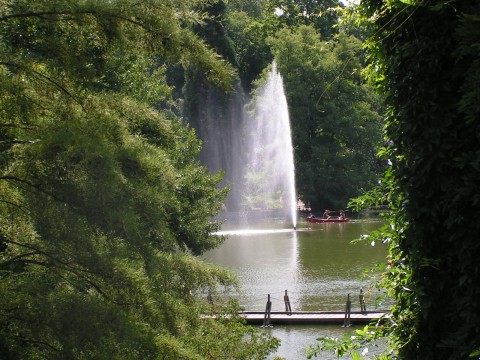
top-left (240, 310), bottom-right (389, 325)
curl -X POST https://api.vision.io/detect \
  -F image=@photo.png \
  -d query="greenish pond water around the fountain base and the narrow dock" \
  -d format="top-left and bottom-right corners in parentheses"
top-left (204, 220), bottom-right (388, 360)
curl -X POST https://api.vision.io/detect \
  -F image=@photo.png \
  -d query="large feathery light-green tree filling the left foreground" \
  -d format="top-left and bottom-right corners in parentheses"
top-left (0, 0), bottom-right (277, 359)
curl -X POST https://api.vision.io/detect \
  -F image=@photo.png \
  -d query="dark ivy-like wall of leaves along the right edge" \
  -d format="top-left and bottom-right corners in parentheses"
top-left (342, 0), bottom-right (480, 359)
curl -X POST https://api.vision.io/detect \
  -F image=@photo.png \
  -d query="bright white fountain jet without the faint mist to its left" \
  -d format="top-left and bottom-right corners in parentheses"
top-left (246, 62), bottom-right (297, 228)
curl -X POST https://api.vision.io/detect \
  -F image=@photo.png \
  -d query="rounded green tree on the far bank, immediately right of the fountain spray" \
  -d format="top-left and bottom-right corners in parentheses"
top-left (271, 26), bottom-right (382, 209)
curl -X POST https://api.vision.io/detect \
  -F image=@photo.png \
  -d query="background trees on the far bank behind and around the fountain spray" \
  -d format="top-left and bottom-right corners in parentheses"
top-left (183, 0), bottom-right (384, 211)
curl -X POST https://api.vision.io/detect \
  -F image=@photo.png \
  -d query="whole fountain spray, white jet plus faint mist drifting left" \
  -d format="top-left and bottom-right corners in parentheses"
top-left (192, 63), bottom-right (297, 228)
